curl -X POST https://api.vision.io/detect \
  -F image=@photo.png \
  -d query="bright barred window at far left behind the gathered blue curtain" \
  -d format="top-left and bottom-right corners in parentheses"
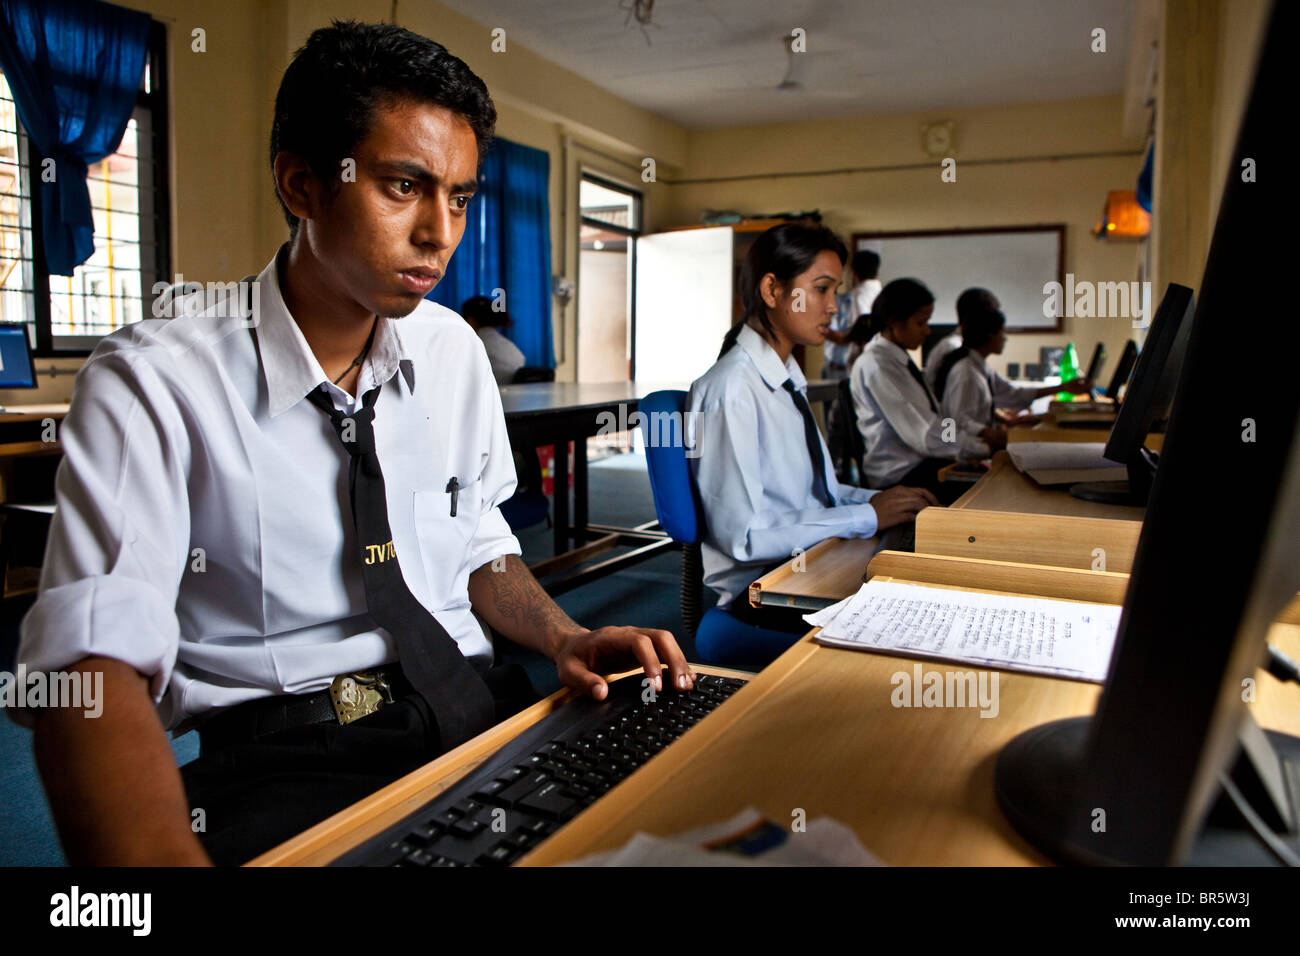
top-left (0, 22), bottom-right (172, 356)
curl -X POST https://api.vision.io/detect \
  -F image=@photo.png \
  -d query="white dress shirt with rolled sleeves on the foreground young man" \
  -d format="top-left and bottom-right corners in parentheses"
top-left (18, 251), bottom-right (520, 728)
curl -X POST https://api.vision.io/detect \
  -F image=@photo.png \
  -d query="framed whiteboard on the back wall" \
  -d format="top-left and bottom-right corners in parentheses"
top-left (853, 225), bottom-right (1065, 332)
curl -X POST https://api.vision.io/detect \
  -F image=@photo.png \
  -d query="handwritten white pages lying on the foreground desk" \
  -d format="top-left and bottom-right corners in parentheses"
top-left (803, 581), bottom-right (1121, 684)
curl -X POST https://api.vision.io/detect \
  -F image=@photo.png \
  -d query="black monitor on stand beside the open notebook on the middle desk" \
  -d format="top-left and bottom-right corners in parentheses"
top-left (1070, 282), bottom-right (1196, 505)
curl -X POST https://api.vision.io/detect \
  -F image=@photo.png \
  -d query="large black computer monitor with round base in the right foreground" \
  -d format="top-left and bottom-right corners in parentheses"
top-left (995, 3), bottom-right (1300, 865)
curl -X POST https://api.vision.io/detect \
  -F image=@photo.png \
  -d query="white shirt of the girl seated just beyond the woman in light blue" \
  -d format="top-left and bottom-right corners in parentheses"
top-left (849, 336), bottom-right (989, 488)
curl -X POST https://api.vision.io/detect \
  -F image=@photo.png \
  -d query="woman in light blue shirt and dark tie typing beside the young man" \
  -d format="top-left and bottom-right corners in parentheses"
top-left (686, 222), bottom-right (937, 633)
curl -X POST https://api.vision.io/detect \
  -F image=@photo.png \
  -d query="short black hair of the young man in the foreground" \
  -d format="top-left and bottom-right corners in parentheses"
top-left (270, 20), bottom-right (497, 234)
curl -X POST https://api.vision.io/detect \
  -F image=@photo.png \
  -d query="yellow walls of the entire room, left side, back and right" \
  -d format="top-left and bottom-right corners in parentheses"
top-left (0, 0), bottom-right (1268, 403)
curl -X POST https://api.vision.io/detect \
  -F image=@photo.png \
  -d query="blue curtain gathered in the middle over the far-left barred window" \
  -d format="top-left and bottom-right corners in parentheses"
top-left (0, 0), bottom-right (150, 276)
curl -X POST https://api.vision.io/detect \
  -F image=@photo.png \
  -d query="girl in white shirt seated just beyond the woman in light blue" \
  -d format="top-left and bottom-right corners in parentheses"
top-left (849, 278), bottom-right (1006, 503)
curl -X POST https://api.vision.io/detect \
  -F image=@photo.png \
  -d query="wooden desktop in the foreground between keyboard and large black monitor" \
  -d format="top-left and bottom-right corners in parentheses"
top-left (521, 613), bottom-right (1300, 866)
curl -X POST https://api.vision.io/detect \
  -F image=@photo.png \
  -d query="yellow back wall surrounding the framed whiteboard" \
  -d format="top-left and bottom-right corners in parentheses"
top-left (666, 96), bottom-right (1141, 371)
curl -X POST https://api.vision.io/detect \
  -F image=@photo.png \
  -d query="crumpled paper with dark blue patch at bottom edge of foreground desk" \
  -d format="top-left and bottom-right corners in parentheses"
top-left (566, 806), bottom-right (883, 866)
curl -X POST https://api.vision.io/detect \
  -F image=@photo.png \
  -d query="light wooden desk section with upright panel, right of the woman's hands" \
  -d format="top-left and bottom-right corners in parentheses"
top-left (917, 451), bottom-right (1145, 571)
